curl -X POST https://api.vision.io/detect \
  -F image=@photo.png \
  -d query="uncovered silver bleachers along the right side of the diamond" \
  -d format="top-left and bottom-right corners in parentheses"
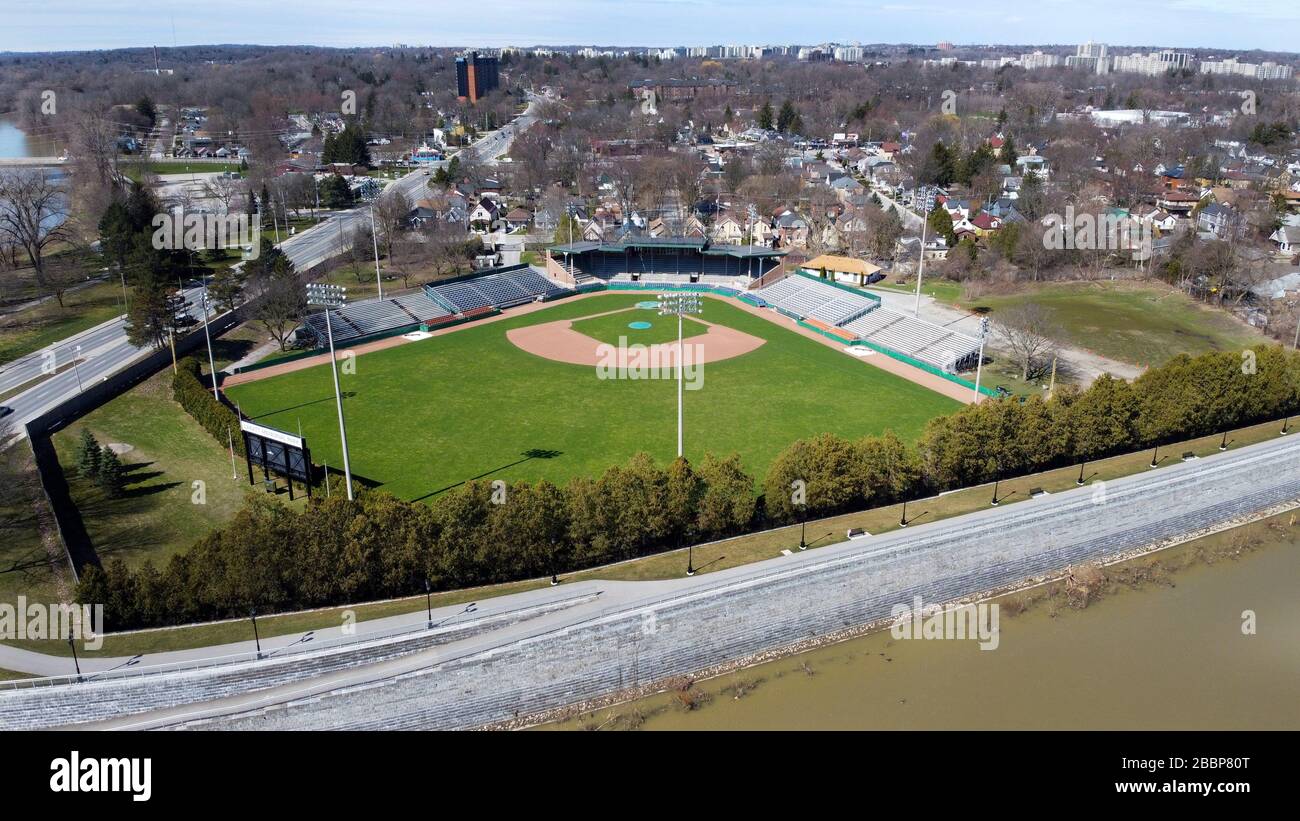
top-left (753, 273), bottom-right (979, 373)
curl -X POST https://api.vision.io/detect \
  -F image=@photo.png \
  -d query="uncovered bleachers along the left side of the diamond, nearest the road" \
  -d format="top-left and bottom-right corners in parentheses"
top-left (304, 265), bottom-right (566, 346)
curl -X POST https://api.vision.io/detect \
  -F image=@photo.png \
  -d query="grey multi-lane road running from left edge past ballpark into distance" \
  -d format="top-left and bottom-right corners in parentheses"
top-left (0, 97), bottom-right (540, 431)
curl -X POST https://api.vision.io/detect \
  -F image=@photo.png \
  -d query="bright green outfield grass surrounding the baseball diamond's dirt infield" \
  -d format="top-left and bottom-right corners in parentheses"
top-left (228, 294), bottom-right (958, 499)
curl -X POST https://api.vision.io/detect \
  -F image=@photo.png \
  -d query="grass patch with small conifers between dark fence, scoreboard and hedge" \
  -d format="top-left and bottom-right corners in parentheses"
top-left (55, 368), bottom-right (279, 565)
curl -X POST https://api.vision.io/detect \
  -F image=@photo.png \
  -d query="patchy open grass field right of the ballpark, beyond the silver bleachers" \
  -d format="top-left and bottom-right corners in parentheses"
top-left (967, 282), bottom-right (1265, 365)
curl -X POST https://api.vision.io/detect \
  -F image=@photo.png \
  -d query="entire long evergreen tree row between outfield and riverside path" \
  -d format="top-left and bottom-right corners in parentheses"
top-left (77, 346), bottom-right (1300, 629)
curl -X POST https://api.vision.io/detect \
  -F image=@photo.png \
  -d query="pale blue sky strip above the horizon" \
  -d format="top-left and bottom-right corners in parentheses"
top-left (0, 0), bottom-right (1300, 52)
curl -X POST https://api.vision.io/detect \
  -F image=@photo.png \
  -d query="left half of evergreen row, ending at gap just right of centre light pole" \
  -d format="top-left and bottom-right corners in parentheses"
top-left (77, 455), bottom-right (755, 630)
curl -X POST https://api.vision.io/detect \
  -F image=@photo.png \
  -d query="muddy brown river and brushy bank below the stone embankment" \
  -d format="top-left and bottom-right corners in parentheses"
top-left (535, 509), bottom-right (1300, 730)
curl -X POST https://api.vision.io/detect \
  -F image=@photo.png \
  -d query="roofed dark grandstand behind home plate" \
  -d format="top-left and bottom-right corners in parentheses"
top-left (547, 236), bottom-right (785, 288)
